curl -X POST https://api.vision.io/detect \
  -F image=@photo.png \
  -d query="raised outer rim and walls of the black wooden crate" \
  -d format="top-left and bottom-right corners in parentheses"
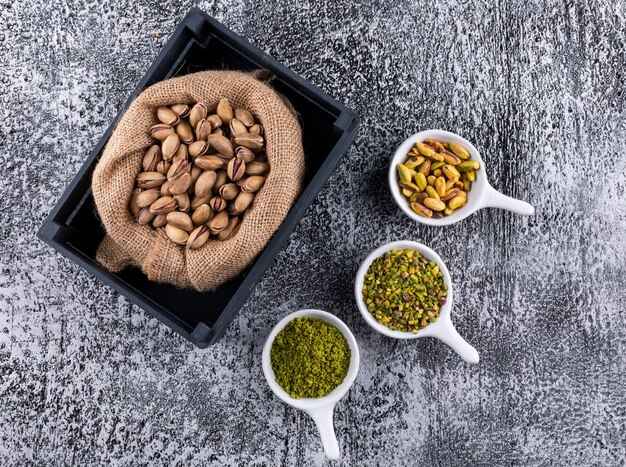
top-left (37, 7), bottom-right (359, 348)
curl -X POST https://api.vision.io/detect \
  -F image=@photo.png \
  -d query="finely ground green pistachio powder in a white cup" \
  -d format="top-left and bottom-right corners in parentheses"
top-left (270, 317), bottom-right (351, 399)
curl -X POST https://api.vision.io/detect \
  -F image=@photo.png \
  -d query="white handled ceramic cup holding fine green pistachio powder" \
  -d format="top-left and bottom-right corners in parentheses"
top-left (262, 310), bottom-right (360, 459)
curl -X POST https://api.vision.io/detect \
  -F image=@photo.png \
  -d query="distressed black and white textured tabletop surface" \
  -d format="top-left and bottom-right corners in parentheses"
top-left (0, 0), bottom-right (626, 466)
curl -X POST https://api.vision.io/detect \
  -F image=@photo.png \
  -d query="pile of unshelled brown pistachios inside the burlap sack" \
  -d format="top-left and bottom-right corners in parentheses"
top-left (130, 99), bottom-right (270, 249)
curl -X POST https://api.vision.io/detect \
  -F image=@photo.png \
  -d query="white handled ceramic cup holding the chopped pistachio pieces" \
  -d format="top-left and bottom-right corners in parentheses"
top-left (354, 240), bottom-right (479, 363)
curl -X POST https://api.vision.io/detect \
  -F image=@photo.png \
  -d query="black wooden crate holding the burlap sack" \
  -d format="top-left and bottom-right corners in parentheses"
top-left (38, 8), bottom-right (359, 348)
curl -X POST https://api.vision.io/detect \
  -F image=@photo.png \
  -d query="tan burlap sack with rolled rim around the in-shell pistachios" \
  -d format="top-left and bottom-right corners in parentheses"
top-left (92, 71), bottom-right (304, 291)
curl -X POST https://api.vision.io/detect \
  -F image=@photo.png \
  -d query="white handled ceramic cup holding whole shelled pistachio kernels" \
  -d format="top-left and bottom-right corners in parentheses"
top-left (389, 130), bottom-right (535, 225)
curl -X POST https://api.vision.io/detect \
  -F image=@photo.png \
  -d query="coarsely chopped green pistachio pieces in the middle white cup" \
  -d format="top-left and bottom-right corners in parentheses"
top-left (362, 249), bottom-right (448, 333)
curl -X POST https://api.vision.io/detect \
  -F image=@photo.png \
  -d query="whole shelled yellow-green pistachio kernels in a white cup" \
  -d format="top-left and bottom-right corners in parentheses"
top-left (397, 138), bottom-right (480, 218)
